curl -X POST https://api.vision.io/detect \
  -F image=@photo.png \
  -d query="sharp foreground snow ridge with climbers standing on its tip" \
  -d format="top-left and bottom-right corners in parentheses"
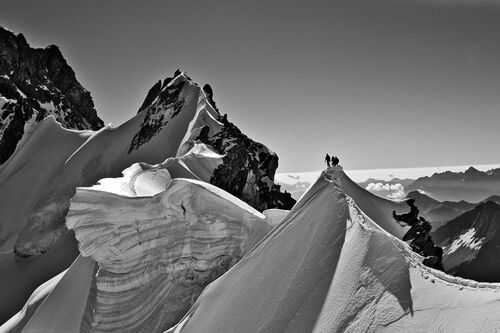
top-left (168, 169), bottom-right (500, 332)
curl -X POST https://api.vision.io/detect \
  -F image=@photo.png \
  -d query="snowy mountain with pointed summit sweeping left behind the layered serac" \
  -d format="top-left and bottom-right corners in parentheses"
top-left (0, 69), bottom-right (294, 320)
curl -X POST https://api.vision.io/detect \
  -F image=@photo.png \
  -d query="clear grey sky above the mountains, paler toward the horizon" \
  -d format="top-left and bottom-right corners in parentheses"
top-left (0, 0), bottom-right (500, 172)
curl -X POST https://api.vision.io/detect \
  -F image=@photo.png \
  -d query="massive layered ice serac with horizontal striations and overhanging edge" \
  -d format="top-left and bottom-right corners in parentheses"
top-left (66, 178), bottom-right (279, 332)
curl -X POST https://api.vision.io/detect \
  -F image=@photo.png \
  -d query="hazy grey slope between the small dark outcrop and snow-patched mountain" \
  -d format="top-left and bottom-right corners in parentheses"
top-left (406, 191), bottom-right (477, 226)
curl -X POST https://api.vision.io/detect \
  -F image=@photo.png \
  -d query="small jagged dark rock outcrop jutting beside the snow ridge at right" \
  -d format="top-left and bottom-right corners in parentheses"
top-left (392, 199), bottom-right (444, 271)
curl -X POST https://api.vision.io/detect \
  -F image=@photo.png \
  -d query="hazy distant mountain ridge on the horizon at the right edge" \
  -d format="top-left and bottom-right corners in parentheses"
top-left (405, 167), bottom-right (500, 202)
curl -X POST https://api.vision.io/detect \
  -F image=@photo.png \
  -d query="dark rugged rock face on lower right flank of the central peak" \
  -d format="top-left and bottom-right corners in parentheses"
top-left (202, 115), bottom-right (296, 211)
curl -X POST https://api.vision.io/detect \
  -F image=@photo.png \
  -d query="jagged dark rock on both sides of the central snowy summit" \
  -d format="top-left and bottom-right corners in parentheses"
top-left (135, 70), bottom-right (295, 211)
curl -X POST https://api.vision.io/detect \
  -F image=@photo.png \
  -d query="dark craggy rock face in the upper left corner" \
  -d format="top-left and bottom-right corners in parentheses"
top-left (0, 27), bottom-right (104, 163)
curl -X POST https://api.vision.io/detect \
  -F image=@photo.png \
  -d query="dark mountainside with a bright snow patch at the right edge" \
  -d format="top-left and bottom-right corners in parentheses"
top-left (432, 201), bottom-right (500, 282)
